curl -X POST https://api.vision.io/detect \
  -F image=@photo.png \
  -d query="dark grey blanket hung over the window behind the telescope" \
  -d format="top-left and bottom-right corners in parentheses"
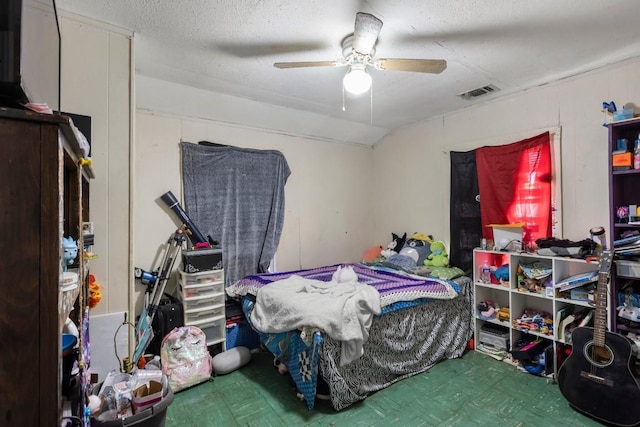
top-left (180, 142), bottom-right (291, 287)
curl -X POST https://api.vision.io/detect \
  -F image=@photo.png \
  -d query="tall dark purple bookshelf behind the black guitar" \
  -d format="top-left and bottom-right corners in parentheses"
top-left (608, 118), bottom-right (640, 334)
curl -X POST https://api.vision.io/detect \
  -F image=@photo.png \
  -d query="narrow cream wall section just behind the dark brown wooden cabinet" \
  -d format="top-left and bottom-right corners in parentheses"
top-left (59, 11), bottom-right (132, 314)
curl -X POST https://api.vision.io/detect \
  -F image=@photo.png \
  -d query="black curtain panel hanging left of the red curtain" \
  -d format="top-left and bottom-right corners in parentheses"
top-left (449, 150), bottom-right (482, 276)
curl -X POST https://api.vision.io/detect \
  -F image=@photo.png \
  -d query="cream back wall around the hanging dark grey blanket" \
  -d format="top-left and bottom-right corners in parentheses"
top-left (133, 92), bottom-right (373, 305)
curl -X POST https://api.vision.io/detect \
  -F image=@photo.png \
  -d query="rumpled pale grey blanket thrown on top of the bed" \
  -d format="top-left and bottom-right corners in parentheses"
top-left (251, 275), bottom-right (380, 366)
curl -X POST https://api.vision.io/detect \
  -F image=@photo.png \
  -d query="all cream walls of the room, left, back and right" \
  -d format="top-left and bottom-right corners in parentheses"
top-left (56, 9), bottom-right (640, 320)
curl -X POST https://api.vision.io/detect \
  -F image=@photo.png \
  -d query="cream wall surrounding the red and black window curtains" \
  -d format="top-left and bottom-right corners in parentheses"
top-left (373, 58), bottom-right (640, 251)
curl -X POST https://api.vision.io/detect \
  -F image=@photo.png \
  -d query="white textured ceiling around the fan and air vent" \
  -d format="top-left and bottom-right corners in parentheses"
top-left (57, 0), bottom-right (640, 145)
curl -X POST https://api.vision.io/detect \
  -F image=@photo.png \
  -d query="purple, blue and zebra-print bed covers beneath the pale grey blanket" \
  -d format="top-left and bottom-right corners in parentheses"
top-left (226, 264), bottom-right (474, 410)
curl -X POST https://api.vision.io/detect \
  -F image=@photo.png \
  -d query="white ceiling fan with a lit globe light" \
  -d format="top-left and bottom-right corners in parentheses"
top-left (273, 12), bottom-right (447, 95)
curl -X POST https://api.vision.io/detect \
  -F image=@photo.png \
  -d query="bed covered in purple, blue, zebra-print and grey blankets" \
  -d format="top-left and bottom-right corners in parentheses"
top-left (227, 264), bottom-right (473, 411)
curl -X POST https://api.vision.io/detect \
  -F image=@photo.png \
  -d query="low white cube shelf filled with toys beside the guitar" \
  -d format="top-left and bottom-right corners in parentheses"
top-left (473, 249), bottom-right (598, 374)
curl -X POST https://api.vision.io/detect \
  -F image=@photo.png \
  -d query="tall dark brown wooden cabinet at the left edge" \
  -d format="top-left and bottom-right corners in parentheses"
top-left (0, 108), bottom-right (93, 427)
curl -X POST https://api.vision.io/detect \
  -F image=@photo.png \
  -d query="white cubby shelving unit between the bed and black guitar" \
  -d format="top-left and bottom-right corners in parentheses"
top-left (473, 249), bottom-right (610, 376)
